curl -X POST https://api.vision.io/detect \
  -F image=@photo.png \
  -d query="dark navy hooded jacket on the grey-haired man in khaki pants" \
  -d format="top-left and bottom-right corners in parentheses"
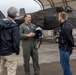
top-left (0, 18), bottom-right (20, 56)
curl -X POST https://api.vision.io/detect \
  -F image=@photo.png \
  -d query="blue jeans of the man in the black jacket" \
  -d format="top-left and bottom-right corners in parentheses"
top-left (60, 50), bottom-right (72, 75)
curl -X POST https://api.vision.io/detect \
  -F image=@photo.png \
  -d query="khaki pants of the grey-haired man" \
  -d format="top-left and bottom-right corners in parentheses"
top-left (0, 53), bottom-right (17, 75)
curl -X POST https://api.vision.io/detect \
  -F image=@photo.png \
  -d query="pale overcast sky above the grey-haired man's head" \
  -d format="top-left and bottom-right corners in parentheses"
top-left (0, 0), bottom-right (41, 15)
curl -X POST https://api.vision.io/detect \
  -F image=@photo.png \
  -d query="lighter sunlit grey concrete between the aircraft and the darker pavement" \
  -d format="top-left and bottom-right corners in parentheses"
top-left (18, 42), bottom-right (76, 65)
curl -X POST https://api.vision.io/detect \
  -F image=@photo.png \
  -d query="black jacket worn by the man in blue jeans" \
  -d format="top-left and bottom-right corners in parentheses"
top-left (59, 21), bottom-right (74, 52)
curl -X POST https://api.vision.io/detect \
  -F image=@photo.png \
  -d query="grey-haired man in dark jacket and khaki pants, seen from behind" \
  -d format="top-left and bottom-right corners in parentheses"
top-left (0, 7), bottom-right (20, 75)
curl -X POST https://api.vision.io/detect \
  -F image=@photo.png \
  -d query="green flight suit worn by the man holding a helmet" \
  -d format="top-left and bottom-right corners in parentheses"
top-left (20, 23), bottom-right (40, 75)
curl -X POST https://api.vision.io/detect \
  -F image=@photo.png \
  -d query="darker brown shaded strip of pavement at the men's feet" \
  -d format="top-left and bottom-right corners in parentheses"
top-left (4, 60), bottom-right (76, 75)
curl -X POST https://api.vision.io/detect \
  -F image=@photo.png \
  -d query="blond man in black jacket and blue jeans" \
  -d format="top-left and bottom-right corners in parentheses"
top-left (58, 12), bottom-right (74, 75)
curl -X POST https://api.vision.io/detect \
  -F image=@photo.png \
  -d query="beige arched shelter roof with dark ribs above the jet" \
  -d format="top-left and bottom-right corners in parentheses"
top-left (34, 0), bottom-right (76, 10)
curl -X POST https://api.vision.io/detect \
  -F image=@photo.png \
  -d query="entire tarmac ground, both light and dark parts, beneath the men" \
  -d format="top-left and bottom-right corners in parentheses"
top-left (4, 42), bottom-right (76, 75)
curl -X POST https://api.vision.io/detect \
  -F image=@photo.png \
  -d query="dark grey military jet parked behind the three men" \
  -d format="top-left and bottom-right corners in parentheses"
top-left (0, 6), bottom-right (76, 30)
